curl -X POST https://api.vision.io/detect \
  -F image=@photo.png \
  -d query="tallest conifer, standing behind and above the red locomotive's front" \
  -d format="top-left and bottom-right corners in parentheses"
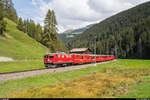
top-left (42, 9), bottom-right (66, 52)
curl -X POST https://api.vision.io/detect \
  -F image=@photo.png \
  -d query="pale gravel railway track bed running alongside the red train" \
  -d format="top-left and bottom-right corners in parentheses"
top-left (0, 60), bottom-right (116, 81)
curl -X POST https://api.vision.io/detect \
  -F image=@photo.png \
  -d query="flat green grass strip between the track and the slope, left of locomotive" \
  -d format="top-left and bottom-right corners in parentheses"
top-left (0, 60), bottom-right (45, 73)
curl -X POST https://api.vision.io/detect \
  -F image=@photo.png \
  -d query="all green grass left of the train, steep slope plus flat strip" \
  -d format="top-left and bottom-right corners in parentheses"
top-left (0, 18), bottom-right (49, 73)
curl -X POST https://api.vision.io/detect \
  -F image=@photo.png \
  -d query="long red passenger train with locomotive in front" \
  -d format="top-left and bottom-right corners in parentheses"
top-left (44, 53), bottom-right (115, 68)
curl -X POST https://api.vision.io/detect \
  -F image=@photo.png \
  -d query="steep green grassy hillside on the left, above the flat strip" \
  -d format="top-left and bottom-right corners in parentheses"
top-left (0, 19), bottom-right (49, 59)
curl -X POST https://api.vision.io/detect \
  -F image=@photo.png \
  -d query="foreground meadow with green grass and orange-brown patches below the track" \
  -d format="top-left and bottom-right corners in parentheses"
top-left (0, 60), bottom-right (150, 98)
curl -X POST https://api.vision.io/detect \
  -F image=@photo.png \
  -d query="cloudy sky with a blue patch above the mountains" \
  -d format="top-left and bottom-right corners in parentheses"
top-left (13, 0), bottom-right (150, 33)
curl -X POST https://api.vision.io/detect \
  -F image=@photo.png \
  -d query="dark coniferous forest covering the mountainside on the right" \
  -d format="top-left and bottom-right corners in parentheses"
top-left (66, 2), bottom-right (150, 59)
